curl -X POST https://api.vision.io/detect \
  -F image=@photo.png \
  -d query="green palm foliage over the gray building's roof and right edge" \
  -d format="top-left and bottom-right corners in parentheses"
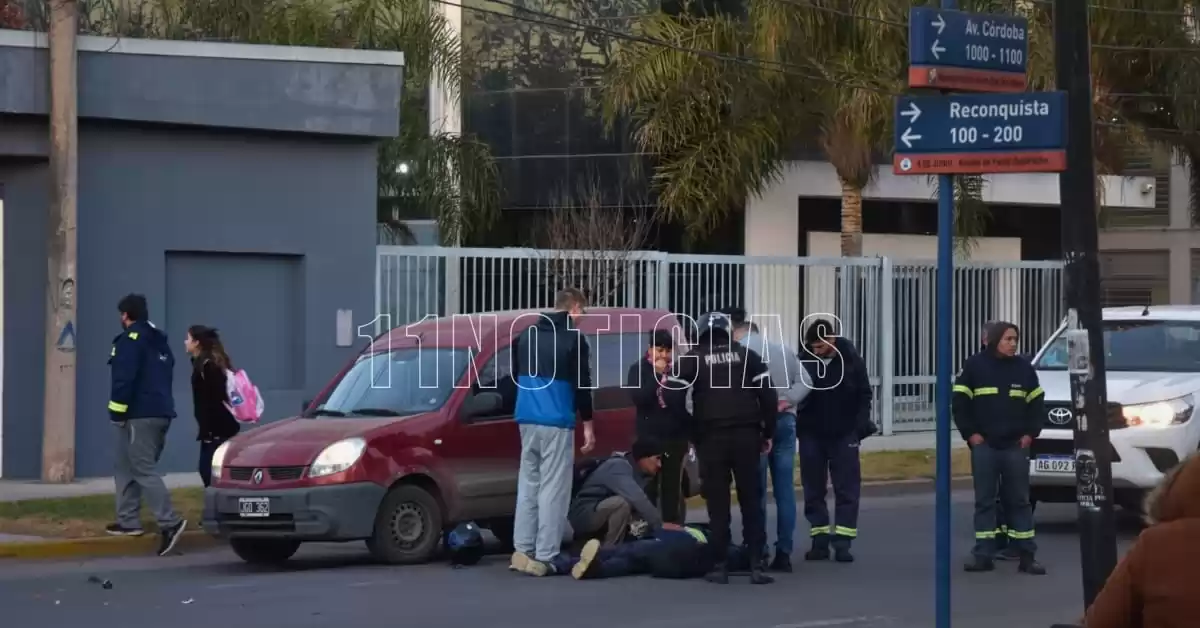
top-left (71, 0), bottom-right (500, 244)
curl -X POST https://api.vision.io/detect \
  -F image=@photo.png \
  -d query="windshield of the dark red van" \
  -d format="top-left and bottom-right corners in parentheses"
top-left (311, 347), bottom-right (470, 417)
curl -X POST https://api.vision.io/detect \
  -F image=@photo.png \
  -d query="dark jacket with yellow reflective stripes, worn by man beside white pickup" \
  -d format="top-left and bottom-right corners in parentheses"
top-left (953, 346), bottom-right (1045, 448)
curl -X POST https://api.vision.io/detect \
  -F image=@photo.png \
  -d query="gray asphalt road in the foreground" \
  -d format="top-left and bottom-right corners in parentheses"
top-left (0, 491), bottom-right (1136, 628)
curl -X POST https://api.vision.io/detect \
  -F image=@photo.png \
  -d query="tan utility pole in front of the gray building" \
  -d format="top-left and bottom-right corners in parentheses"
top-left (42, 0), bottom-right (79, 483)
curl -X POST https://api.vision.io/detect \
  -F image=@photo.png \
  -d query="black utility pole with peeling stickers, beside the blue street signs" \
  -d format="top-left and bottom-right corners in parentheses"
top-left (1054, 0), bottom-right (1117, 606)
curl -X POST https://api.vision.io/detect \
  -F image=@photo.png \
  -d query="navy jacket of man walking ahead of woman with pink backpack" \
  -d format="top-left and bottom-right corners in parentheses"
top-left (108, 321), bottom-right (175, 421)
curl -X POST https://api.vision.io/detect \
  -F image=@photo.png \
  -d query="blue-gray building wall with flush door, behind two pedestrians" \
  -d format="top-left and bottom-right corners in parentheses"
top-left (0, 122), bottom-right (376, 477)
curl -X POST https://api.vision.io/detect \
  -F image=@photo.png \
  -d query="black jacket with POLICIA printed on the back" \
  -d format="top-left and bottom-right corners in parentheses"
top-left (664, 333), bottom-right (779, 442)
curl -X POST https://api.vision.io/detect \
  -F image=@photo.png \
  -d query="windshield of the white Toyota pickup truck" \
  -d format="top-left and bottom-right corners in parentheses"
top-left (1034, 321), bottom-right (1200, 372)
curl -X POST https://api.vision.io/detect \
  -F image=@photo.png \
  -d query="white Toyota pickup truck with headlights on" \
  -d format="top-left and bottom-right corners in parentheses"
top-left (1030, 306), bottom-right (1200, 512)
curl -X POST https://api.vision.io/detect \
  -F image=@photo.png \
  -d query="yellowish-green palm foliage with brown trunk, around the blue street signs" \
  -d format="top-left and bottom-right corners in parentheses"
top-left (606, 0), bottom-right (1200, 256)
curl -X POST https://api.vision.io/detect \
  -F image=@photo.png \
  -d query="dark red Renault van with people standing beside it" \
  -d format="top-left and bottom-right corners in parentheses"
top-left (204, 309), bottom-right (700, 563)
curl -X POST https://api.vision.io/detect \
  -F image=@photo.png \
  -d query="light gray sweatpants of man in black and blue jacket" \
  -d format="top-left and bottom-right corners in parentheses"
top-left (512, 425), bottom-right (575, 562)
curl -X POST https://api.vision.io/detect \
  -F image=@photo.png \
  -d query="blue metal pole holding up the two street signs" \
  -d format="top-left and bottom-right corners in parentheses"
top-left (935, 0), bottom-right (958, 628)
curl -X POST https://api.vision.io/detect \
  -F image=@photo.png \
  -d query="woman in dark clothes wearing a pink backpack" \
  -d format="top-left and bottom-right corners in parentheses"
top-left (184, 325), bottom-right (263, 486)
